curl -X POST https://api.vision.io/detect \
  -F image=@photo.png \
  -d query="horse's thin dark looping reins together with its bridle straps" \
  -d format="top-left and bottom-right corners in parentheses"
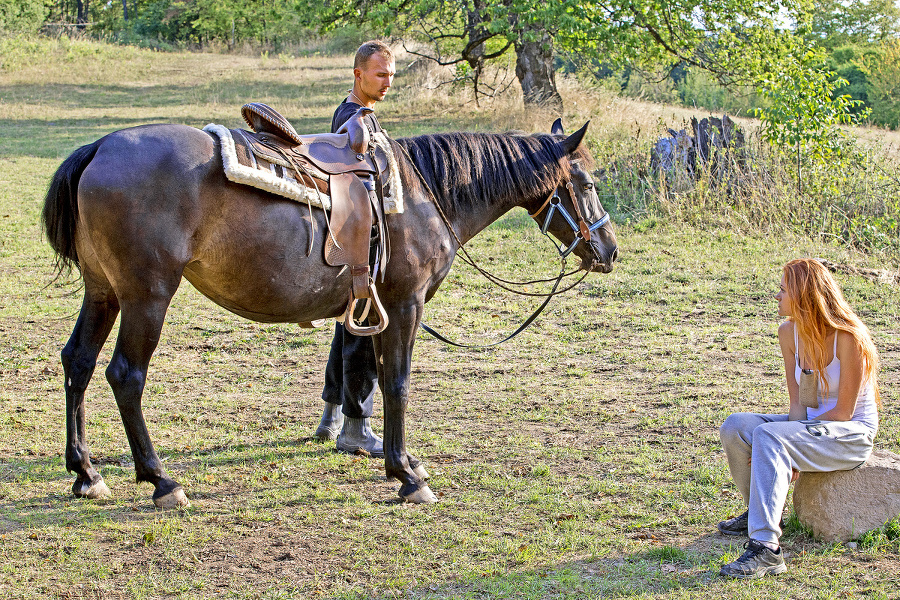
top-left (400, 146), bottom-right (610, 348)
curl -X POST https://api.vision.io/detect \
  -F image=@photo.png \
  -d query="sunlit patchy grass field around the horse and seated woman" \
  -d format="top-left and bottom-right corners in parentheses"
top-left (0, 42), bottom-right (900, 599)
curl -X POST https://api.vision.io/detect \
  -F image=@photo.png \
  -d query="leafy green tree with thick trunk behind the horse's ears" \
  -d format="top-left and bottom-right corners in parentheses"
top-left (322, 0), bottom-right (807, 107)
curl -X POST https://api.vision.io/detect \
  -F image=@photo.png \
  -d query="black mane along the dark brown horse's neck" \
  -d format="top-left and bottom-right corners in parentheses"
top-left (397, 132), bottom-right (593, 213)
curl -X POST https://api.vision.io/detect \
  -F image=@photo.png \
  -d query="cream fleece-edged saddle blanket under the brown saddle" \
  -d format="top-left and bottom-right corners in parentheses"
top-left (203, 123), bottom-right (403, 214)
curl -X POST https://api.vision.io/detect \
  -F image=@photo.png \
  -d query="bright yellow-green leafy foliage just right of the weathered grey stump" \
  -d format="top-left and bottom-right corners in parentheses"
top-left (755, 52), bottom-right (868, 163)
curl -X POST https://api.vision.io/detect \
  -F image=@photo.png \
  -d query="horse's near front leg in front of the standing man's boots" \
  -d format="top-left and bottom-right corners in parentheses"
top-left (375, 301), bottom-right (437, 504)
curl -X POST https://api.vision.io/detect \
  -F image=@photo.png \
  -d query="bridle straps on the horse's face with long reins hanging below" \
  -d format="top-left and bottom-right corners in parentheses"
top-left (398, 144), bottom-right (596, 348)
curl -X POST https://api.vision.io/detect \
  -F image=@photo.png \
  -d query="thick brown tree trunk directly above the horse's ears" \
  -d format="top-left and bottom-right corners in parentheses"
top-left (516, 25), bottom-right (563, 115)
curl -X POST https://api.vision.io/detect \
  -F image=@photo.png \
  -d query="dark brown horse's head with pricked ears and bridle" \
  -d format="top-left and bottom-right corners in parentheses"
top-left (531, 119), bottom-right (619, 273)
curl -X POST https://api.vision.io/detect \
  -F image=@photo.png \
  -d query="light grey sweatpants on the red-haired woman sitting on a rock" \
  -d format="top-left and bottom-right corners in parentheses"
top-left (719, 413), bottom-right (875, 544)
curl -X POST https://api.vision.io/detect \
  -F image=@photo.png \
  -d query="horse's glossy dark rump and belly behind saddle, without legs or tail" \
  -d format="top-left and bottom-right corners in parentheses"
top-left (78, 125), bottom-right (349, 322)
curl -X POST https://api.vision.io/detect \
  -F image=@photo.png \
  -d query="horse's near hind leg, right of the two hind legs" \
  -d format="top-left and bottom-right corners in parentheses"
top-left (106, 292), bottom-right (190, 508)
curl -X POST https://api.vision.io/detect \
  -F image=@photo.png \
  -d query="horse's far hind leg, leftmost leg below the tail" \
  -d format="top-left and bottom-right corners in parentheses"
top-left (62, 275), bottom-right (119, 498)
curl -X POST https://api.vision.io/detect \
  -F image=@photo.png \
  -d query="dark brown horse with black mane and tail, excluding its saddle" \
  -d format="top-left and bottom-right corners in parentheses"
top-left (43, 117), bottom-right (617, 507)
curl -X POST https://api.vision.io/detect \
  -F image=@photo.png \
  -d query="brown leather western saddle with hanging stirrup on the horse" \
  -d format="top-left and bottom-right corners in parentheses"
top-left (231, 102), bottom-right (389, 335)
